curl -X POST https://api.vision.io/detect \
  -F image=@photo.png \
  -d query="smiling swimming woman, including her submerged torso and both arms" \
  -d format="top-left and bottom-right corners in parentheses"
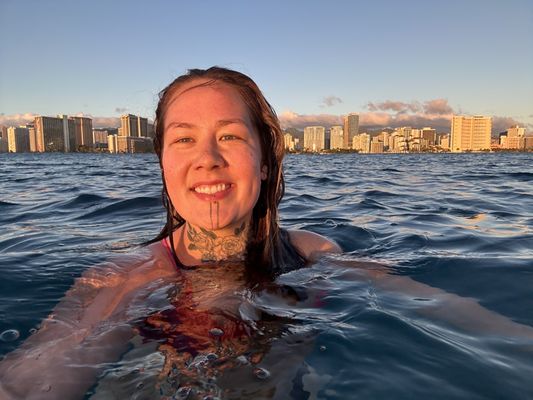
top-left (0, 67), bottom-right (533, 399)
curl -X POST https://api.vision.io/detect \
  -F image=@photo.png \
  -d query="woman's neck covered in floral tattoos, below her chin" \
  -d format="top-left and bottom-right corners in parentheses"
top-left (182, 222), bottom-right (249, 263)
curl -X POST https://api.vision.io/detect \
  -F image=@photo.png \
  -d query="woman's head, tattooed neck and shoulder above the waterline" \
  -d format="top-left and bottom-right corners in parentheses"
top-left (150, 67), bottom-right (340, 273)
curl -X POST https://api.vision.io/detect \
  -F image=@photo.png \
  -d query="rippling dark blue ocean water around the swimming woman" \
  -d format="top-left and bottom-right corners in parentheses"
top-left (0, 153), bottom-right (533, 399)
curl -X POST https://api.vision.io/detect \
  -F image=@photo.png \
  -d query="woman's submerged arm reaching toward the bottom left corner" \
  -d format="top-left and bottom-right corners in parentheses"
top-left (0, 245), bottom-right (177, 399)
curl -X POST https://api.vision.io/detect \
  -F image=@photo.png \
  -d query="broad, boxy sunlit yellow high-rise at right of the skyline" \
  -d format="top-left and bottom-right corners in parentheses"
top-left (451, 115), bottom-right (492, 153)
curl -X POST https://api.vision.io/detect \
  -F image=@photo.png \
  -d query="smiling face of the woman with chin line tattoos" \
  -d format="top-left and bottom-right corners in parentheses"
top-left (162, 80), bottom-right (266, 232)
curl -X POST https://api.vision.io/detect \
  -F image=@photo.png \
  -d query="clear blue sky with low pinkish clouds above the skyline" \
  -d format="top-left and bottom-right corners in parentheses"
top-left (0, 0), bottom-right (533, 133)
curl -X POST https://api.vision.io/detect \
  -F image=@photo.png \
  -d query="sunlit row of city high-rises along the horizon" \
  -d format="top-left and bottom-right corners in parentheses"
top-left (0, 113), bottom-right (533, 153)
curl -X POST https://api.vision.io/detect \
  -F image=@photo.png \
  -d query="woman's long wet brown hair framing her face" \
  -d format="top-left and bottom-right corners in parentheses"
top-left (150, 66), bottom-right (303, 275)
